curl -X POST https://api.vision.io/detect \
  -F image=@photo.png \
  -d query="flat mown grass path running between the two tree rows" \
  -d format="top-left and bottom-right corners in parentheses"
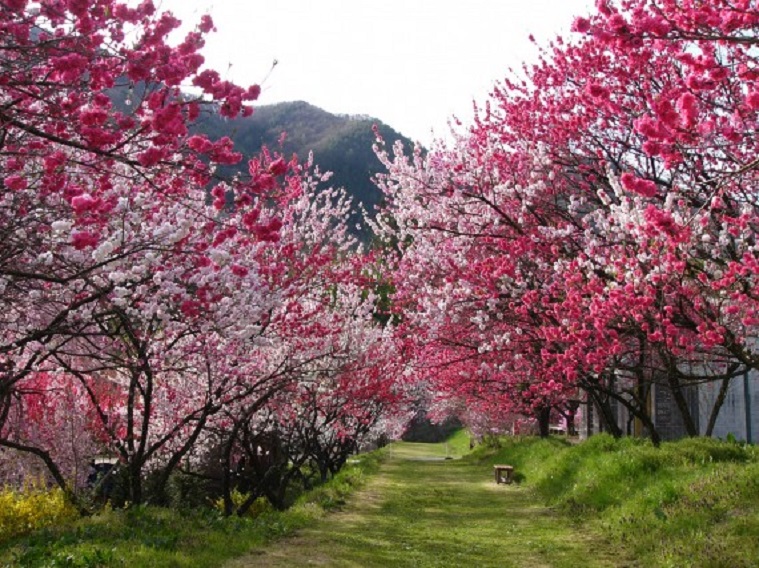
top-left (228, 443), bottom-right (626, 568)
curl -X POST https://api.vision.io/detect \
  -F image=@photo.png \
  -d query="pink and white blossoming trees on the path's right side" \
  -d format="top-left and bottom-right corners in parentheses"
top-left (374, 0), bottom-right (759, 441)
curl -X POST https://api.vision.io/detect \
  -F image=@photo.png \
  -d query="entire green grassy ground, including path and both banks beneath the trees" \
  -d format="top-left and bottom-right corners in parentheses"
top-left (0, 432), bottom-right (759, 567)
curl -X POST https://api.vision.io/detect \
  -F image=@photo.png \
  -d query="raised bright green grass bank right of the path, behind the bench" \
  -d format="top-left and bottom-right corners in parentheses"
top-left (470, 435), bottom-right (759, 568)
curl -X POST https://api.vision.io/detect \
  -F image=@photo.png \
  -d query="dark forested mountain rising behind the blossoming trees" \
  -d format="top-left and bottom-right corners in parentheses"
top-left (193, 101), bottom-right (411, 221)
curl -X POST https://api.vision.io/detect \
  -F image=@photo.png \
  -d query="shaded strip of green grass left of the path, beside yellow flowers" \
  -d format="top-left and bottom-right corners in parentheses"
top-left (0, 450), bottom-right (385, 568)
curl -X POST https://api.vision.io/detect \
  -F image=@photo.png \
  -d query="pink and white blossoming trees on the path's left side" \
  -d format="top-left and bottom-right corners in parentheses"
top-left (0, 0), bottom-right (410, 512)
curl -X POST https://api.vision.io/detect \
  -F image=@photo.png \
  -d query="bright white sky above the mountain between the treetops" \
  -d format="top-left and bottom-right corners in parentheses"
top-left (156, 0), bottom-right (592, 144)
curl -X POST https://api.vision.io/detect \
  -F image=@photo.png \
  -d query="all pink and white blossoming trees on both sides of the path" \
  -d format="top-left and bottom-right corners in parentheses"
top-left (0, 0), bottom-right (759, 513)
